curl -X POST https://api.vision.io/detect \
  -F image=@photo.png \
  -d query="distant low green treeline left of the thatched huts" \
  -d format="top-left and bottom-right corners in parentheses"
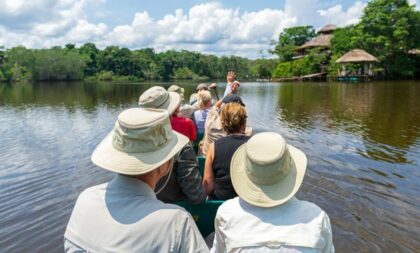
top-left (0, 43), bottom-right (275, 82)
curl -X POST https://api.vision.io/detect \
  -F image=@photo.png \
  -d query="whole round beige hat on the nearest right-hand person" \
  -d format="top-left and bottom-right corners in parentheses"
top-left (230, 132), bottom-right (307, 207)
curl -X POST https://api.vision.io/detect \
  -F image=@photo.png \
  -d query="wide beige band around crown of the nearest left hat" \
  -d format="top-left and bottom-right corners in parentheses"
top-left (112, 118), bottom-right (174, 153)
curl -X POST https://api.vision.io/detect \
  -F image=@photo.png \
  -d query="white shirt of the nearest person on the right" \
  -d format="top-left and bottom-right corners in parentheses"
top-left (210, 197), bottom-right (334, 253)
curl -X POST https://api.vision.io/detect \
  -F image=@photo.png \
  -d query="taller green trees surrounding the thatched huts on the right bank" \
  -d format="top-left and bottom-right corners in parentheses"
top-left (273, 0), bottom-right (420, 78)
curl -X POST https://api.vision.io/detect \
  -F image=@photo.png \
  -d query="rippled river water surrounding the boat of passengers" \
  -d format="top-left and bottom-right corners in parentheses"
top-left (0, 81), bottom-right (420, 252)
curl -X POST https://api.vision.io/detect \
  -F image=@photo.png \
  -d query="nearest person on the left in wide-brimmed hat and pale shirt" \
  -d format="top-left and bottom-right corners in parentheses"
top-left (64, 108), bottom-right (208, 252)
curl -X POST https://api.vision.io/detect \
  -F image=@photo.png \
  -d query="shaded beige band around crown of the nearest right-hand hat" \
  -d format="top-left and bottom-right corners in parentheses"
top-left (246, 149), bottom-right (292, 185)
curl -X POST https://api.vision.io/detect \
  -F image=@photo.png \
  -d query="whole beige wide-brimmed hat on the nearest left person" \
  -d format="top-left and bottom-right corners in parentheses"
top-left (92, 108), bottom-right (188, 175)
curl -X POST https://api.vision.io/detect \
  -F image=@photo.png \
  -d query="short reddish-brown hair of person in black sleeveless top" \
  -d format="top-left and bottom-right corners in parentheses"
top-left (220, 103), bottom-right (247, 134)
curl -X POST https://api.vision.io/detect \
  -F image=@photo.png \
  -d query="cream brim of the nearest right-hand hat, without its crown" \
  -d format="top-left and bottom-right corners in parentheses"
top-left (230, 144), bottom-right (307, 207)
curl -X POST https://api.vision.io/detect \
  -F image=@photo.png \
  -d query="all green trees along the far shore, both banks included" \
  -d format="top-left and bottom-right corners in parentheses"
top-left (0, 0), bottom-right (420, 82)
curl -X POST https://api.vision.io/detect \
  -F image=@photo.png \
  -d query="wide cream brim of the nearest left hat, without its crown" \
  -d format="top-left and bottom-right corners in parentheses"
top-left (91, 131), bottom-right (188, 175)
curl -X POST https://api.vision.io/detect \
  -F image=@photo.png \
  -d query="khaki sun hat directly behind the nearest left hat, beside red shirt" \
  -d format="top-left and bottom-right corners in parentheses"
top-left (139, 86), bottom-right (181, 115)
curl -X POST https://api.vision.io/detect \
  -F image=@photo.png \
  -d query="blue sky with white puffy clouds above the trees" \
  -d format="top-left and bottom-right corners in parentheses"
top-left (0, 0), bottom-right (420, 58)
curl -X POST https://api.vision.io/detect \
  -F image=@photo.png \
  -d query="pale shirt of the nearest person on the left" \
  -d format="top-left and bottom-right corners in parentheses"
top-left (64, 175), bottom-right (208, 252)
